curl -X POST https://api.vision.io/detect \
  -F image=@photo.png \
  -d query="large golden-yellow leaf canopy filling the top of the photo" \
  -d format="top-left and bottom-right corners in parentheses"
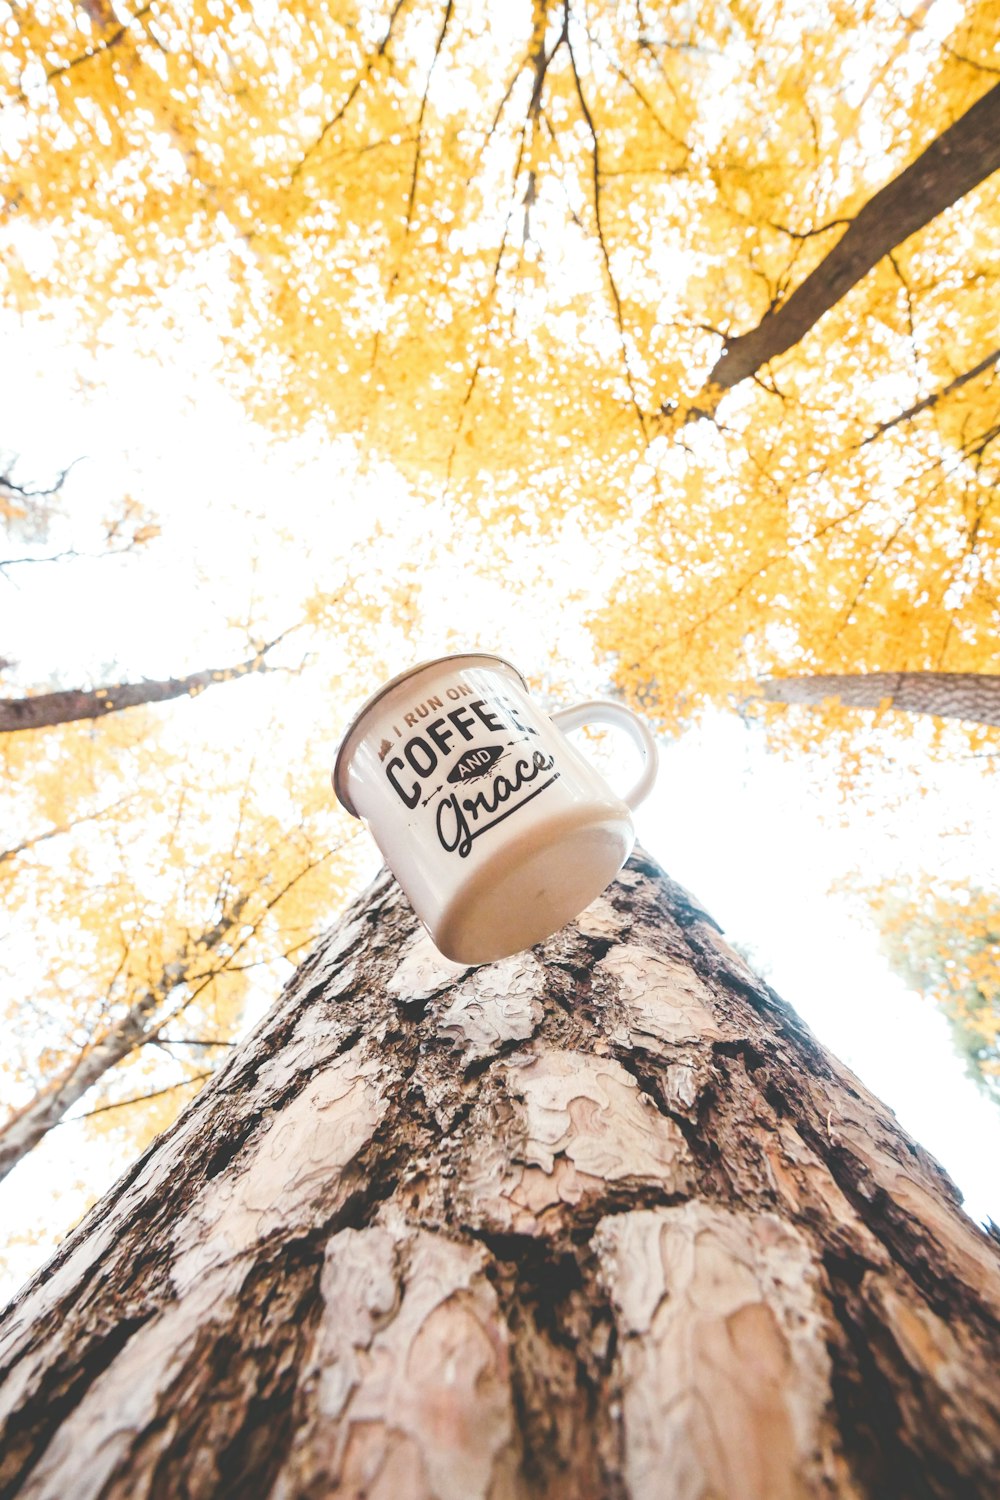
top-left (0, 0), bottom-right (1000, 722)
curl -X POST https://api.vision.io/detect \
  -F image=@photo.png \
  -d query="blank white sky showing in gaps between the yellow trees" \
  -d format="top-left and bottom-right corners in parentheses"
top-left (0, 304), bottom-right (1000, 1295)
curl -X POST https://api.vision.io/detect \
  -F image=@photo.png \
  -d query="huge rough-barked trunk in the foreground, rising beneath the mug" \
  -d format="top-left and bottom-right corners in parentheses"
top-left (0, 857), bottom-right (1000, 1500)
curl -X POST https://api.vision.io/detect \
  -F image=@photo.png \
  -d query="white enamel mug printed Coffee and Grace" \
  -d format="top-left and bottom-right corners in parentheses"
top-left (333, 653), bottom-right (657, 963)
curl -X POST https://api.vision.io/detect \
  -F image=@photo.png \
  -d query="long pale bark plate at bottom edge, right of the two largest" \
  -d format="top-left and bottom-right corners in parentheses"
top-left (595, 1203), bottom-right (844, 1500)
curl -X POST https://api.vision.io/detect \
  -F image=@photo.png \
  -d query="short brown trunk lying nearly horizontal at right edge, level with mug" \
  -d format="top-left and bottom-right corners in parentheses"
top-left (762, 672), bottom-right (1000, 725)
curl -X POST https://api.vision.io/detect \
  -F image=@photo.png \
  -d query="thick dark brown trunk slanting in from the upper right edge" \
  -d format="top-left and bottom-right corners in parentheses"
top-left (664, 84), bottom-right (1000, 428)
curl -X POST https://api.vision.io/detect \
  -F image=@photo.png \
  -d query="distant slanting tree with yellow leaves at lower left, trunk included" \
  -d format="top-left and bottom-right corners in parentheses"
top-left (0, 728), bottom-right (359, 1179)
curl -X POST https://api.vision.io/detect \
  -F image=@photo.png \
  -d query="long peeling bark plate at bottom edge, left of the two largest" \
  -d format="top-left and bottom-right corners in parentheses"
top-left (273, 1224), bottom-right (523, 1500)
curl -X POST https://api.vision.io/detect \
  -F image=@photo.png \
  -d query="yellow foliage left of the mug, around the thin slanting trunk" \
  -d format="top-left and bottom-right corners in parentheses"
top-left (0, 711), bottom-right (352, 1124)
